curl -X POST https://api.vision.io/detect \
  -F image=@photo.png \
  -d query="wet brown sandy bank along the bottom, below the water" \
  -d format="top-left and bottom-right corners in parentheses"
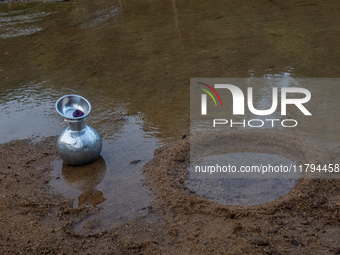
top-left (0, 134), bottom-right (340, 254)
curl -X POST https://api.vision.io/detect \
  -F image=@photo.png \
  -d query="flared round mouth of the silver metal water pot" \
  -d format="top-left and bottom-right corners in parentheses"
top-left (55, 95), bottom-right (91, 120)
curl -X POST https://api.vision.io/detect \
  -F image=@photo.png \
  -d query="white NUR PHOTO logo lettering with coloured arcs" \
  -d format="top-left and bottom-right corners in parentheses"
top-left (195, 79), bottom-right (312, 128)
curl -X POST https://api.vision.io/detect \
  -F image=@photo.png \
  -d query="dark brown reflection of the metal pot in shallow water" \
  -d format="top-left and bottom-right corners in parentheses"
top-left (62, 157), bottom-right (106, 207)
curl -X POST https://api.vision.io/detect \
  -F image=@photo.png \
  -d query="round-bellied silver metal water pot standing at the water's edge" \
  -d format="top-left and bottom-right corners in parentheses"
top-left (55, 95), bottom-right (102, 165)
